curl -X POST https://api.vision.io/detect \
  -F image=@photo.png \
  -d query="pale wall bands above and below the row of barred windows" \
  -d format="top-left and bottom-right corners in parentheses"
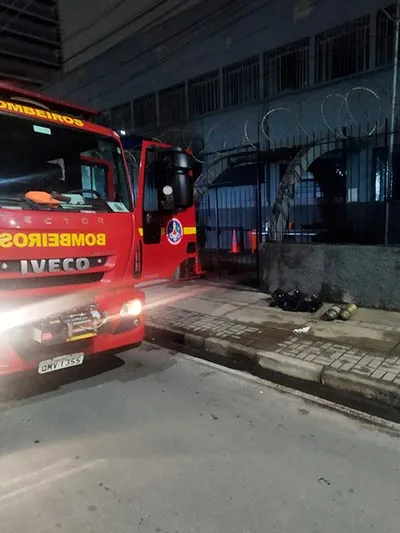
top-left (47, 0), bottom-right (391, 153)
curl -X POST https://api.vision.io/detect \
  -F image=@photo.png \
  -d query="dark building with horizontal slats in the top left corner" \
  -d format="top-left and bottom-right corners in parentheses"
top-left (0, 0), bottom-right (62, 88)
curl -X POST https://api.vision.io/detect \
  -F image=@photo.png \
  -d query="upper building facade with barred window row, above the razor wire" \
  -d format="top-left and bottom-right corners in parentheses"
top-left (47, 0), bottom-right (394, 139)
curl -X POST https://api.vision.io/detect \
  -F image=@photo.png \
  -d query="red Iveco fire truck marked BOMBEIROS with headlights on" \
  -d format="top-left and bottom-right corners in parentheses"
top-left (0, 83), bottom-right (193, 375)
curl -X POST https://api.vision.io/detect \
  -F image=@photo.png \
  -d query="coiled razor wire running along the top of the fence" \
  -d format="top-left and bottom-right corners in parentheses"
top-left (133, 80), bottom-right (390, 164)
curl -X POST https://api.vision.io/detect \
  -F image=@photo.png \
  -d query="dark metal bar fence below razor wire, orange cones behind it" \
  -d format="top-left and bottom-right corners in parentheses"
top-left (197, 122), bottom-right (400, 276)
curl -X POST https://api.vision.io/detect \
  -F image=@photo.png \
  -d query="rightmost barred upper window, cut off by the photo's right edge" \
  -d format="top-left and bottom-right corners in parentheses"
top-left (375, 4), bottom-right (400, 67)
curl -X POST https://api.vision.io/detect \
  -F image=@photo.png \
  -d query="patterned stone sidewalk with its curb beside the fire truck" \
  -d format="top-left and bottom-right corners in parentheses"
top-left (145, 280), bottom-right (400, 407)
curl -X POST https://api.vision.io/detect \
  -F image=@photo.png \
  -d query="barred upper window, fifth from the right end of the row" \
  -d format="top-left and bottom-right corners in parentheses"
top-left (188, 70), bottom-right (221, 118)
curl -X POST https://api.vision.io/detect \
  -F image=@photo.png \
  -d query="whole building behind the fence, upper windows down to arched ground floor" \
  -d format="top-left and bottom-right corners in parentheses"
top-left (47, 0), bottom-right (400, 306)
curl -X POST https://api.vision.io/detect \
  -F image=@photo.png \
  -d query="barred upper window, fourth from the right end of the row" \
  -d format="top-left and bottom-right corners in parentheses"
top-left (222, 56), bottom-right (260, 108)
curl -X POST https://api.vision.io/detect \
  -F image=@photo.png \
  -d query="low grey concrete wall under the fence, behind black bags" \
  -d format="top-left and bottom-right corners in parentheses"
top-left (260, 243), bottom-right (400, 311)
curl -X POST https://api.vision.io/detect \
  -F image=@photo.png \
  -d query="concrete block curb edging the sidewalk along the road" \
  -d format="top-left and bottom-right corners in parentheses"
top-left (145, 324), bottom-right (400, 409)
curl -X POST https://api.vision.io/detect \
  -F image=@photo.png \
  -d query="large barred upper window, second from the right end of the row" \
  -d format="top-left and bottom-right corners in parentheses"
top-left (315, 15), bottom-right (370, 83)
